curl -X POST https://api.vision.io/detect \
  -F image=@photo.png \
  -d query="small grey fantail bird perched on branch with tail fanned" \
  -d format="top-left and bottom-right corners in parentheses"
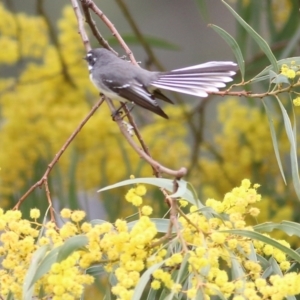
top-left (85, 48), bottom-right (237, 119)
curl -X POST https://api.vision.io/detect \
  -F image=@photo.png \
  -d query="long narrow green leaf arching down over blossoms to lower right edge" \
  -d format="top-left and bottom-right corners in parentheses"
top-left (220, 229), bottom-right (300, 262)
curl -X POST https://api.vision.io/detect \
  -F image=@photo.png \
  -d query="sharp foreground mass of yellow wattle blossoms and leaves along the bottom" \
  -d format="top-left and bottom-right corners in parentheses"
top-left (0, 179), bottom-right (300, 300)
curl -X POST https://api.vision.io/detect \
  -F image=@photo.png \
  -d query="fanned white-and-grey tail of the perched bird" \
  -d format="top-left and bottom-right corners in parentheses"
top-left (151, 61), bottom-right (237, 97)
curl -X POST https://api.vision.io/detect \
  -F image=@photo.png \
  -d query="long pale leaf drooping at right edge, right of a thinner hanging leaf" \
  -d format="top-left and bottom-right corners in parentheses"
top-left (275, 96), bottom-right (300, 200)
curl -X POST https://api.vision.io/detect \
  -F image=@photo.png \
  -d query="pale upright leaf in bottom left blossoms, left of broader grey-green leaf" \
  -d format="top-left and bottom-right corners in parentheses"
top-left (23, 245), bottom-right (50, 300)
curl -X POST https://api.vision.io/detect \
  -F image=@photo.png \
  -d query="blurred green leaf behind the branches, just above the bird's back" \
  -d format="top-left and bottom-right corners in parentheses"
top-left (107, 33), bottom-right (180, 51)
